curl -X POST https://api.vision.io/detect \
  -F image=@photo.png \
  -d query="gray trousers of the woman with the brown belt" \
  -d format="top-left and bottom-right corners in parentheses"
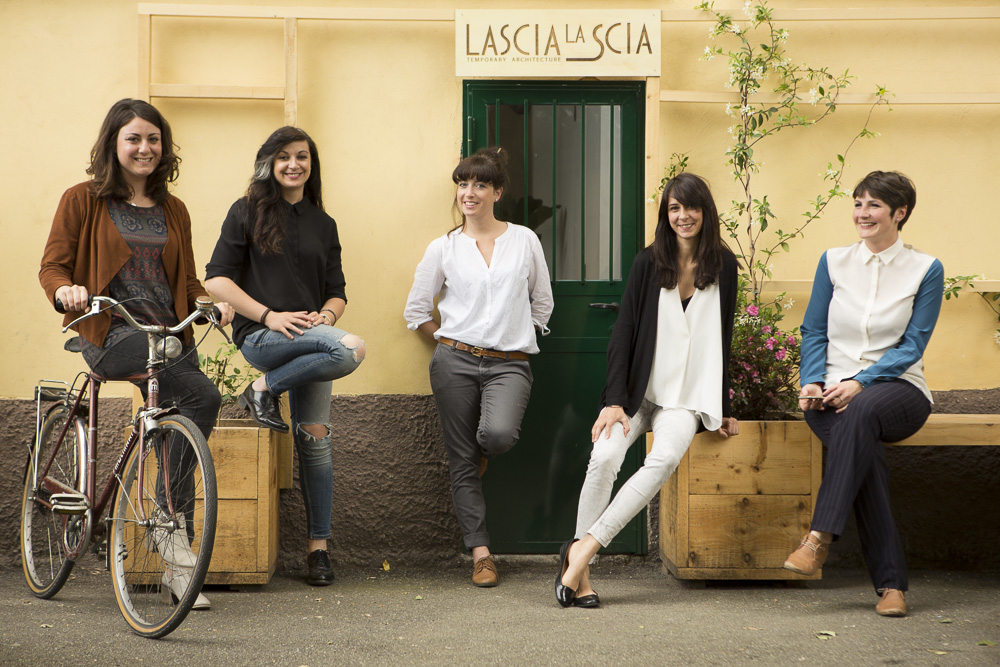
top-left (430, 345), bottom-right (532, 549)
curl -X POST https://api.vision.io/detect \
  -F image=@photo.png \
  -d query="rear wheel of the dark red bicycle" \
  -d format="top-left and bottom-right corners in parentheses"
top-left (21, 404), bottom-right (82, 599)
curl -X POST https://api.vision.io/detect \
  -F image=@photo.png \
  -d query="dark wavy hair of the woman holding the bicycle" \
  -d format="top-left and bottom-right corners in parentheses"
top-left (87, 97), bottom-right (181, 204)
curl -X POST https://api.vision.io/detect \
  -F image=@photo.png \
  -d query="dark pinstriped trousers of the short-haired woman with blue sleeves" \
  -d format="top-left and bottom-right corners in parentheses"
top-left (805, 379), bottom-right (931, 591)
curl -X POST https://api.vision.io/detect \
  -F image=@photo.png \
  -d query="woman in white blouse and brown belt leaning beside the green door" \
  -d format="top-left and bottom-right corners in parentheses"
top-left (404, 148), bottom-right (552, 587)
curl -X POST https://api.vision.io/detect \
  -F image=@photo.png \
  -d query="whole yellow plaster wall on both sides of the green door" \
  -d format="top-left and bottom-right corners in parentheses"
top-left (0, 0), bottom-right (1000, 398)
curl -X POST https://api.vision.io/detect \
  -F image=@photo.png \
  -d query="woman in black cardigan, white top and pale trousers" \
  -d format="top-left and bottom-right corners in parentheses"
top-left (555, 173), bottom-right (739, 607)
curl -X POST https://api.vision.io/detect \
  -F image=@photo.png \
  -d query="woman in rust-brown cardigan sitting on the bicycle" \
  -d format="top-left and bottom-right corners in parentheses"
top-left (38, 99), bottom-right (233, 609)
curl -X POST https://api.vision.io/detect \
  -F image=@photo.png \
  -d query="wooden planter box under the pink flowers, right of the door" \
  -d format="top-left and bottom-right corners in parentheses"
top-left (660, 421), bottom-right (823, 579)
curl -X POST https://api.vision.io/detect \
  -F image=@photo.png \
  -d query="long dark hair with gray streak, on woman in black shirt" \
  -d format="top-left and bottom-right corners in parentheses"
top-left (247, 125), bottom-right (323, 254)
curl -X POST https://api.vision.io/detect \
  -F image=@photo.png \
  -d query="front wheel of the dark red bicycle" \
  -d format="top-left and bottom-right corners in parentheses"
top-left (109, 415), bottom-right (218, 638)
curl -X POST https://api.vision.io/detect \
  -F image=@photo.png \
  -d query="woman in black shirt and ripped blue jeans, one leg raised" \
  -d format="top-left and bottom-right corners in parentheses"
top-left (206, 127), bottom-right (365, 586)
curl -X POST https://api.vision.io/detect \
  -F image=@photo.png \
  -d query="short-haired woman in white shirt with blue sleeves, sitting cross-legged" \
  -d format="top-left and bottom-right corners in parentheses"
top-left (785, 171), bottom-right (944, 616)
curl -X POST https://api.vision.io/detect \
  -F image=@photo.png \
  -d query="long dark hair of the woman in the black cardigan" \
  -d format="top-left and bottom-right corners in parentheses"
top-left (652, 172), bottom-right (730, 289)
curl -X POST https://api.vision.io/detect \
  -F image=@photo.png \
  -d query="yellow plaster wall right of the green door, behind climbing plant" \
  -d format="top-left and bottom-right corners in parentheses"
top-left (660, 7), bottom-right (1000, 390)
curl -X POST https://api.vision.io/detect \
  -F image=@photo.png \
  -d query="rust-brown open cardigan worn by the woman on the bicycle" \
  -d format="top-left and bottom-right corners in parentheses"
top-left (38, 182), bottom-right (208, 347)
